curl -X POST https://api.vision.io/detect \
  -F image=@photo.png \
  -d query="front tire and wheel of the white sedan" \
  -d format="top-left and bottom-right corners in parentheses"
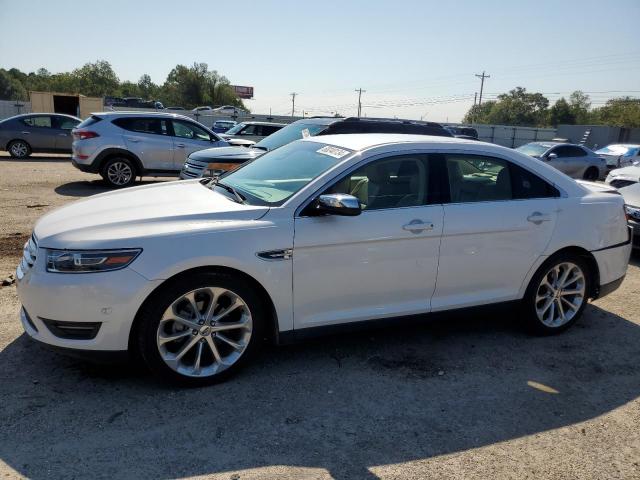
top-left (137, 272), bottom-right (268, 387)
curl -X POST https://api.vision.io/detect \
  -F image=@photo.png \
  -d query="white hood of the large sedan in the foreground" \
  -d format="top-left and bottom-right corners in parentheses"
top-left (34, 180), bottom-right (269, 249)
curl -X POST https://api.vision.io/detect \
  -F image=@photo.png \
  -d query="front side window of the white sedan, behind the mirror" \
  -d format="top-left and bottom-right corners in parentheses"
top-left (324, 155), bottom-right (429, 210)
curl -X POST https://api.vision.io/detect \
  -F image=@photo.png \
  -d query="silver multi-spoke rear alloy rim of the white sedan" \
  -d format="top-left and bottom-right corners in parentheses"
top-left (535, 262), bottom-right (586, 328)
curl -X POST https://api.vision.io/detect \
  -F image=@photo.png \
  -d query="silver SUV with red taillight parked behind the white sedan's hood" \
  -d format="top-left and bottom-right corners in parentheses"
top-left (71, 112), bottom-right (229, 187)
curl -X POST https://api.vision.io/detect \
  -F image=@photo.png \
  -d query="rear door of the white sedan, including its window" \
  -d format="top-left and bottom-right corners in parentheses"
top-left (431, 154), bottom-right (558, 311)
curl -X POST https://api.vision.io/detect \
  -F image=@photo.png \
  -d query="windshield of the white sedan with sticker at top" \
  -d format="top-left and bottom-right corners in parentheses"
top-left (220, 142), bottom-right (352, 206)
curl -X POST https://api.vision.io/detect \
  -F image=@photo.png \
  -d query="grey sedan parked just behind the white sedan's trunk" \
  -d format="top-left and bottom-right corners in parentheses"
top-left (516, 142), bottom-right (607, 180)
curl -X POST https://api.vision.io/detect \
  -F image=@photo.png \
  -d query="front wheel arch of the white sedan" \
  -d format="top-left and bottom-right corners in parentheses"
top-left (129, 265), bottom-right (279, 354)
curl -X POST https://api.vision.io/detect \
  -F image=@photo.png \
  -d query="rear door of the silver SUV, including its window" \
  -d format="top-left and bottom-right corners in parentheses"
top-left (113, 116), bottom-right (176, 171)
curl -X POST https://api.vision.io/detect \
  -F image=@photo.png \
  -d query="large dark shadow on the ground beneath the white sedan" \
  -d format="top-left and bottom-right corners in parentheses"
top-left (0, 305), bottom-right (640, 479)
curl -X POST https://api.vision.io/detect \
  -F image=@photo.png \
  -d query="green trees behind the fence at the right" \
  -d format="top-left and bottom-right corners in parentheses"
top-left (463, 87), bottom-right (640, 127)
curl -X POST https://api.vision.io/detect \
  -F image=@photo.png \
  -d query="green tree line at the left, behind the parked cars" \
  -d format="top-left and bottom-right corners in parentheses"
top-left (0, 60), bottom-right (245, 108)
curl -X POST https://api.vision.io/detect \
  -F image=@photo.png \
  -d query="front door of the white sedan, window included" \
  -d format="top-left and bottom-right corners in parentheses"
top-left (293, 155), bottom-right (443, 329)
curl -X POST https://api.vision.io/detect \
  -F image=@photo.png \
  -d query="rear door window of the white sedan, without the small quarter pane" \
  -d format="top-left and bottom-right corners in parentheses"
top-left (445, 154), bottom-right (512, 203)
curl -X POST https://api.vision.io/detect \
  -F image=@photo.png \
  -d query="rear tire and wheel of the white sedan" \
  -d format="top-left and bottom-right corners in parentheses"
top-left (522, 253), bottom-right (592, 335)
